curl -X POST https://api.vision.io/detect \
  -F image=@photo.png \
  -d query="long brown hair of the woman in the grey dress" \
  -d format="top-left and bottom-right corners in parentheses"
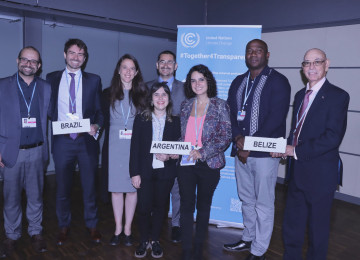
top-left (110, 54), bottom-right (147, 113)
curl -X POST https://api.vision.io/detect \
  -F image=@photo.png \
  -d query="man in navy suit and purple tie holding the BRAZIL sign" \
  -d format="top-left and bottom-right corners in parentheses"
top-left (46, 39), bottom-right (103, 245)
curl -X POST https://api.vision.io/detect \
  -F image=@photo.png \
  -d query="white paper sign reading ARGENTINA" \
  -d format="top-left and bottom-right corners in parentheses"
top-left (150, 141), bottom-right (191, 155)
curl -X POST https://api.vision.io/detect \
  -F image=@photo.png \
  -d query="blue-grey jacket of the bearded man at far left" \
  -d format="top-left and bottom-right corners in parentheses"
top-left (0, 74), bottom-right (51, 168)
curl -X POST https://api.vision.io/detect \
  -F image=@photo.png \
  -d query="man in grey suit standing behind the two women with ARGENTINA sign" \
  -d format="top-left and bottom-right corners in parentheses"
top-left (146, 50), bottom-right (185, 243)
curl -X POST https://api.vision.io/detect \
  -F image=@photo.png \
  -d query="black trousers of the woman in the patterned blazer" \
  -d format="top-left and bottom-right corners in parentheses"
top-left (178, 162), bottom-right (220, 251)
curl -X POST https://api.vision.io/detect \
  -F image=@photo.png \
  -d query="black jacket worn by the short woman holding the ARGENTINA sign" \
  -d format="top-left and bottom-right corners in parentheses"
top-left (130, 114), bottom-right (180, 179)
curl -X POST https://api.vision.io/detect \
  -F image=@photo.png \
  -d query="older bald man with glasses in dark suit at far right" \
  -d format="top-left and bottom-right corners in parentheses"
top-left (276, 49), bottom-right (350, 260)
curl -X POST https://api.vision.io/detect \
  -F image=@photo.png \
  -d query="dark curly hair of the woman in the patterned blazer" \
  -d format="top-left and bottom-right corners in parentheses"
top-left (184, 64), bottom-right (217, 98)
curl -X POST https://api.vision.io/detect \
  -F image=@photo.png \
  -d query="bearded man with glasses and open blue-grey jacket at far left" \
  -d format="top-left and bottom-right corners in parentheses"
top-left (0, 46), bottom-right (51, 255)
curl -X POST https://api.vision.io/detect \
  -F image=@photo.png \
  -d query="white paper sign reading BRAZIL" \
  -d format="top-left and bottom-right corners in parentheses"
top-left (52, 118), bottom-right (90, 135)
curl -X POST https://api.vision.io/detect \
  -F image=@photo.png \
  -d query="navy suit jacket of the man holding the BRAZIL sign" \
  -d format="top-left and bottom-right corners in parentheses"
top-left (46, 70), bottom-right (104, 151)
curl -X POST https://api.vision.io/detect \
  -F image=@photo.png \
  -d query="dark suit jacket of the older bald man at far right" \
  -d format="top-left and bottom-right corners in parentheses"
top-left (288, 80), bottom-right (350, 194)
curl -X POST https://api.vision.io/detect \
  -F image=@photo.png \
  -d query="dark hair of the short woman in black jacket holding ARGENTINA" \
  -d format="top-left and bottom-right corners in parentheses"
top-left (142, 82), bottom-right (172, 122)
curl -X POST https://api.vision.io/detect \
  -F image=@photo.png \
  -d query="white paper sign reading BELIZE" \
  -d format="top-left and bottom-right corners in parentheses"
top-left (244, 136), bottom-right (286, 153)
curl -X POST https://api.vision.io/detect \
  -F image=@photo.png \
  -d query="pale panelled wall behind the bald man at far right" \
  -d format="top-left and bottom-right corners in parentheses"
top-left (262, 25), bottom-right (360, 198)
